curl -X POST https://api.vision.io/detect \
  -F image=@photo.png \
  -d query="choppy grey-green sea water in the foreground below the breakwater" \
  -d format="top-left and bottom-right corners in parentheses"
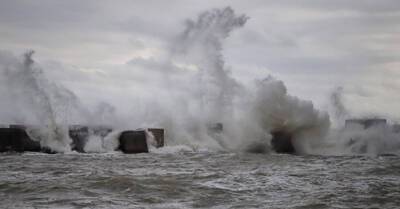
top-left (0, 149), bottom-right (400, 208)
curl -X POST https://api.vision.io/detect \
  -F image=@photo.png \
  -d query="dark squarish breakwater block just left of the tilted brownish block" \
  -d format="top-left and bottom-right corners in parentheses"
top-left (119, 130), bottom-right (149, 153)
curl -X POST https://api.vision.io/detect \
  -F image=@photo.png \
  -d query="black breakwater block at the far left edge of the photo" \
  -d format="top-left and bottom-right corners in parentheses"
top-left (0, 125), bottom-right (42, 152)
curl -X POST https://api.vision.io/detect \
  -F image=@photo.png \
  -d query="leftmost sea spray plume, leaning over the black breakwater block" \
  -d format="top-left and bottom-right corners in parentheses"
top-left (1, 51), bottom-right (78, 152)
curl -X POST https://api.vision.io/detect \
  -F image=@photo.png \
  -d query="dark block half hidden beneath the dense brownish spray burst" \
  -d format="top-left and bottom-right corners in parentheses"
top-left (271, 131), bottom-right (296, 153)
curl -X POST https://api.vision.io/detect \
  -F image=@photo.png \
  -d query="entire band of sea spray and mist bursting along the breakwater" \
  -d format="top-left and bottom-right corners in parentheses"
top-left (0, 7), bottom-right (400, 155)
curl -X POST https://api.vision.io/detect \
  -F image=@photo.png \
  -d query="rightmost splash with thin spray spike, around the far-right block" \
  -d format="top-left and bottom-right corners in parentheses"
top-left (324, 87), bottom-right (400, 156)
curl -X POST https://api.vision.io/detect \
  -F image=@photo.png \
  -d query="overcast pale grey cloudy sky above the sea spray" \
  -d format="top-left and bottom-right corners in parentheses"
top-left (0, 0), bottom-right (400, 120)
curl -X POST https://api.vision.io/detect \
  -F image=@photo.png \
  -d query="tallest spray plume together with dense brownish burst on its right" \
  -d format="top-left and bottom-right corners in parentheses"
top-left (161, 7), bottom-right (329, 151)
